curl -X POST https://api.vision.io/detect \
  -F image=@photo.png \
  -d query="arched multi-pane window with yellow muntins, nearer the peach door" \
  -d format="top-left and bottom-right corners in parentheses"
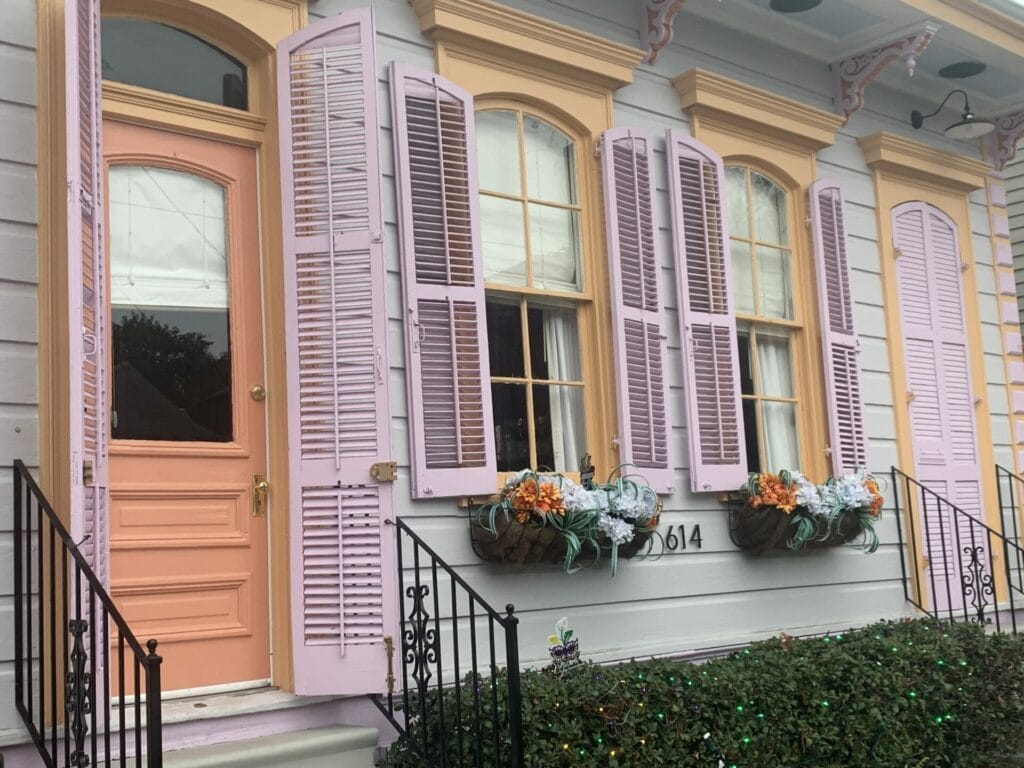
top-left (476, 109), bottom-right (591, 472)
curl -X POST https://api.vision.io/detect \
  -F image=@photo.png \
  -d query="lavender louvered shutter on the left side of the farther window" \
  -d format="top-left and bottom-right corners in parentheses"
top-left (667, 130), bottom-right (746, 492)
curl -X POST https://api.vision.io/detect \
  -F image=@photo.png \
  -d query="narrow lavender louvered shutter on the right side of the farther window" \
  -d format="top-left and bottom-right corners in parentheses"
top-left (810, 179), bottom-right (867, 476)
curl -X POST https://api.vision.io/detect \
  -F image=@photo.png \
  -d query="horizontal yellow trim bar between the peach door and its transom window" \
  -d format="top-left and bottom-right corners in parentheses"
top-left (103, 80), bottom-right (267, 146)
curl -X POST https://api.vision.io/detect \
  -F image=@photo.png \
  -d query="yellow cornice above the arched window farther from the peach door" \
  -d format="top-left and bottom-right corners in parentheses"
top-left (672, 69), bottom-right (843, 151)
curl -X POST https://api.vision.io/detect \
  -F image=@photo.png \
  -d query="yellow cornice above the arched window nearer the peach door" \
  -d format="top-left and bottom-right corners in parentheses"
top-left (410, 0), bottom-right (645, 90)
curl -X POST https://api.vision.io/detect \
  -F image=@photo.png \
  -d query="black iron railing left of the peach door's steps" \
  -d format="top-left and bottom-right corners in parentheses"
top-left (13, 461), bottom-right (163, 768)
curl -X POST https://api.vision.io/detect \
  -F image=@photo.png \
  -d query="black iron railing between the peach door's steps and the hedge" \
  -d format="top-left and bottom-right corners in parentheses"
top-left (374, 519), bottom-right (523, 768)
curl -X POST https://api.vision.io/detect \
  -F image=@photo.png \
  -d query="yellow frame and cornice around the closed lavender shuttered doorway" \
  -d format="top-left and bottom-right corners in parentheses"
top-left (865, 160), bottom-right (1005, 606)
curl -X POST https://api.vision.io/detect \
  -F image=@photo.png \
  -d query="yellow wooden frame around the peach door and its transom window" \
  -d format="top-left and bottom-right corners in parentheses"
top-left (37, 0), bottom-right (307, 689)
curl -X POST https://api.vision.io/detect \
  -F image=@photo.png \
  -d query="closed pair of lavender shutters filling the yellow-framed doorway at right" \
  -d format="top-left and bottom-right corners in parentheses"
top-left (892, 203), bottom-right (988, 610)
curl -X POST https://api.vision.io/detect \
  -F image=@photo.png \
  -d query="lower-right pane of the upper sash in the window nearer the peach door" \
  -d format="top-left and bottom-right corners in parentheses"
top-left (529, 203), bottom-right (583, 291)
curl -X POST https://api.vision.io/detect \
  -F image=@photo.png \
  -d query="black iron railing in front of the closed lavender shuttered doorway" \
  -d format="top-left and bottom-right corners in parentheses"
top-left (892, 467), bottom-right (1024, 633)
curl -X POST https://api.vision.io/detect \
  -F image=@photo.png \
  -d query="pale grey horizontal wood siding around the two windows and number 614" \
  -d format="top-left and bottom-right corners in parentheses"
top-left (301, 0), bottom-right (937, 660)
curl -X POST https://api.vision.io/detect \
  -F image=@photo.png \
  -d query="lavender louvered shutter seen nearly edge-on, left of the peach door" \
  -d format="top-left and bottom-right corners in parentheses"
top-left (65, 0), bottom-right (110, 584)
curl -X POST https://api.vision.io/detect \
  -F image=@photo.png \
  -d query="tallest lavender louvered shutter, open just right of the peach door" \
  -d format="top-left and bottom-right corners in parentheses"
top-left (278, 10), bottom-right (397, 693)
